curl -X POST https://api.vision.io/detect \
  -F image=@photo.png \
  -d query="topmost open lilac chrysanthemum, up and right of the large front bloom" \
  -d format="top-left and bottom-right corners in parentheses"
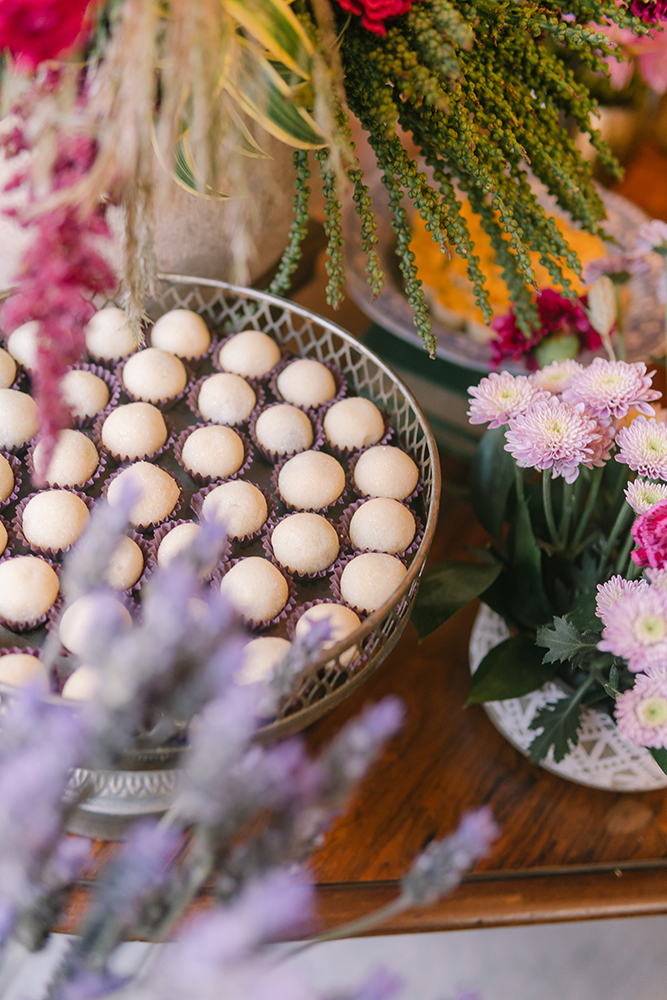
top-left (563, 358), bottom-right (660, 420)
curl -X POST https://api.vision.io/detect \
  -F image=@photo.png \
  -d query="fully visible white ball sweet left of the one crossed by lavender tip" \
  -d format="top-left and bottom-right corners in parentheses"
top-left (220, 556), bottom-right (289, 624)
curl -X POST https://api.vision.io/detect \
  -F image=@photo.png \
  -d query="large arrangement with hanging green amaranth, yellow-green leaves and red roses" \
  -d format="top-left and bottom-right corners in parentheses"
top-left (0, 0), bottom-right (655, 452)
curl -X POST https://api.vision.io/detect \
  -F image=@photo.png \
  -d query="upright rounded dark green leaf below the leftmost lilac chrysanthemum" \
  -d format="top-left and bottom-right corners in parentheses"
top-left (470, 427), bottom-right (514, 542)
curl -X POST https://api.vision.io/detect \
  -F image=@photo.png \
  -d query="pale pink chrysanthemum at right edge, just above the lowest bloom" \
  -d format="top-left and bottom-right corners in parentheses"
top-left (598, 587), bottom-right (667, 673)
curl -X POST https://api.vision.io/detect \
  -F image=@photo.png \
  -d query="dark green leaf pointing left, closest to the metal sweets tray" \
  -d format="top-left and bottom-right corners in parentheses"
top-left (412, 560), bottom-right (501, 642)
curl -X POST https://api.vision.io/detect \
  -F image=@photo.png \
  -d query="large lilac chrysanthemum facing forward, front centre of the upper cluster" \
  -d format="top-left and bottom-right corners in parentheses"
top-left (505, 396), bottom-right (600, 483)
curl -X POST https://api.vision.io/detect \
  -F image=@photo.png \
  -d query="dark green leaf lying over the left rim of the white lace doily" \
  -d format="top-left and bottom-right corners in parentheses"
top-left (466, 632), bottom-right (554, 705)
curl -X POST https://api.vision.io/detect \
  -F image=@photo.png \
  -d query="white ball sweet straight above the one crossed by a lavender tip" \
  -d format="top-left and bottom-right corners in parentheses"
top-left (271, 512), bottom-right (340, 576)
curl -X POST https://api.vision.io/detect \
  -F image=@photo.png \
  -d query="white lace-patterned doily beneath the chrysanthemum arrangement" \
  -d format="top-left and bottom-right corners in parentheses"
top-left (469, 604), bottom-right (667, 792)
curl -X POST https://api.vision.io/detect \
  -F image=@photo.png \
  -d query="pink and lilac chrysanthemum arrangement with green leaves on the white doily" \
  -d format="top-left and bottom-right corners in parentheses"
top-left (414, 348), bottom-right (667, 770)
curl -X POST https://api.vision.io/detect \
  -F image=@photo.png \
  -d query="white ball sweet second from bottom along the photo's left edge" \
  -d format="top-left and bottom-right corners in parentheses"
top-left (0, 556), bottom-right (59, 625)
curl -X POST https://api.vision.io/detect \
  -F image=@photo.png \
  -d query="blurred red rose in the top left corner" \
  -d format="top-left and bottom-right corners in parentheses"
top-left (0, 0), bottom-right (95, 69)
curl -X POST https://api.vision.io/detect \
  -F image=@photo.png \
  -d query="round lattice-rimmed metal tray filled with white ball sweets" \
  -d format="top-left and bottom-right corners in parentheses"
top-left (0, 276), bottom-right (439, 738)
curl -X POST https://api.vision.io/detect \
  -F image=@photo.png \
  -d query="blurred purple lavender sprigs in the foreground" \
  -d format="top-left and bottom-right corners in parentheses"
top-left (0, 494), bottom-right (497, 1000)
